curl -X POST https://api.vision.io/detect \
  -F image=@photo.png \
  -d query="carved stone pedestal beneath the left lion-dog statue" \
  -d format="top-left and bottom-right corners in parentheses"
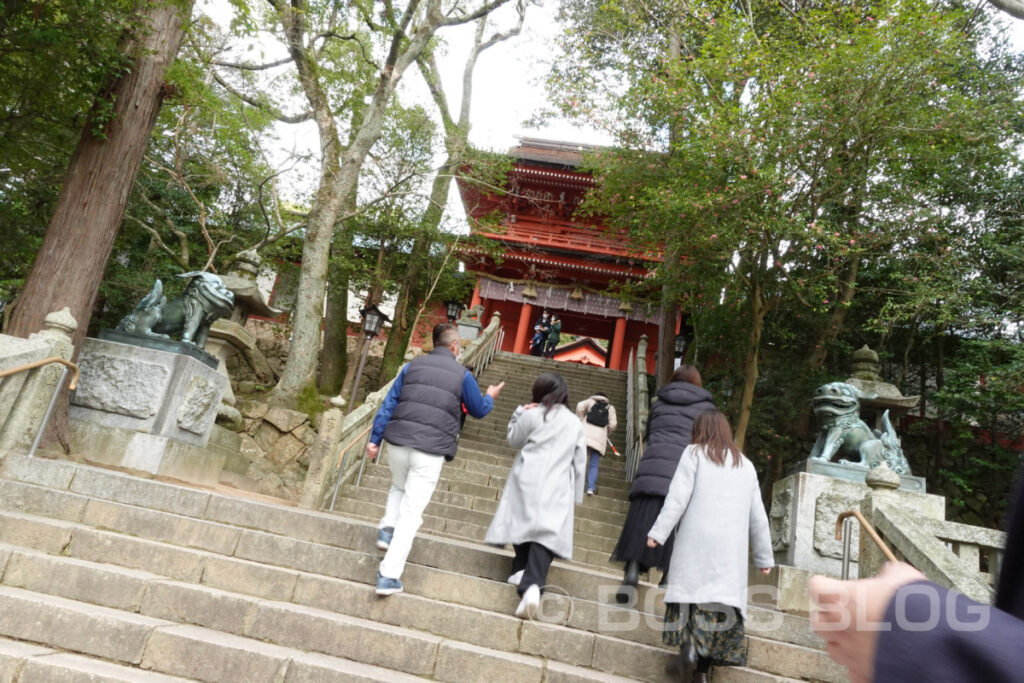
top-left (70, 338), bottom-right (228, 483)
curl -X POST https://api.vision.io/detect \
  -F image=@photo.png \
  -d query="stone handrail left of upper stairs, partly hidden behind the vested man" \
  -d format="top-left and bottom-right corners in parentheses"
top-left (299, 312), bottom-right (504, 508)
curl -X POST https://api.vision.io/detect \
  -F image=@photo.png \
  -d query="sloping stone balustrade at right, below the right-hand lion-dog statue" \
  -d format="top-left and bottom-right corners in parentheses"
top-left (861, 501), bottom-right (1006, 604)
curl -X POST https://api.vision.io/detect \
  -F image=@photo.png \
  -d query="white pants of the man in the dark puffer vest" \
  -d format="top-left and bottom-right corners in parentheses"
top-left (377, 443), bottom-right (444, 579)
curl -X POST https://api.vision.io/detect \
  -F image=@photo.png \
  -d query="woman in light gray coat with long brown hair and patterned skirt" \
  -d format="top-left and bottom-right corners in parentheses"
top-left (647, 411), bottom-right (775, 683)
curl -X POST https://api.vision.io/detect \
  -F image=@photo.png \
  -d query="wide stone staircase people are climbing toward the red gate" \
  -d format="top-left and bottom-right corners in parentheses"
top-left (0, 354), bottom-right (846, 683)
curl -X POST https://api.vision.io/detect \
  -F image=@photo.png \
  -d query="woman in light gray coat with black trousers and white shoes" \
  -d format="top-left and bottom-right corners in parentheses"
top-left (484, 373), bottom-right (587, 618)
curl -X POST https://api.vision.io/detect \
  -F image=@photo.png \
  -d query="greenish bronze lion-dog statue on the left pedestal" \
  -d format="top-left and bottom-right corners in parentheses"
top-left (117, 270), bottom-right (234, 348)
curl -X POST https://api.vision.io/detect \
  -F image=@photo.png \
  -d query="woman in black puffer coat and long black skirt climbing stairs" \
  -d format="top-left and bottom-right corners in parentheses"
top-left (611, 365), bottom-right (715, 603)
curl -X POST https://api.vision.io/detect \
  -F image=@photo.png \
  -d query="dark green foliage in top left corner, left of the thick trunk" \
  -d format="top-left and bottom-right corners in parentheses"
top-left (0, 0), bottom-right (135, 307)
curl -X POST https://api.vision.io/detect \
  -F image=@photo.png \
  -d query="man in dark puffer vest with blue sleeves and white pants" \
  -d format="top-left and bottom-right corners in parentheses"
top-left (367, 323), bottom-right (505, 595)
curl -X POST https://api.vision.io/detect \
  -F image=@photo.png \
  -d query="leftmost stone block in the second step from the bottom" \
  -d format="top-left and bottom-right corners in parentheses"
top-left (0, 586), bottom-right (166, 664)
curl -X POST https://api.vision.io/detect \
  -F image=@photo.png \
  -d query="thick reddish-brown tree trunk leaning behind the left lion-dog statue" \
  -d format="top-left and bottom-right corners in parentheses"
top-left (7, 0), bottom-right (191, 450)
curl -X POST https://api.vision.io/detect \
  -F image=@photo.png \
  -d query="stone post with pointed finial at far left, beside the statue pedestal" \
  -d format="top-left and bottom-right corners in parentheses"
top-left (0, 307), bottom-right (78, 452)
